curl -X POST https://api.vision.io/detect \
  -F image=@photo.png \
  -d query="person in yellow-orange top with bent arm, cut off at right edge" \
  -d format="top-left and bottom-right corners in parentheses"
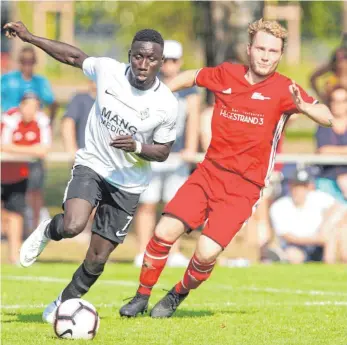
top-left (310, 33), bottom-right (347, 103)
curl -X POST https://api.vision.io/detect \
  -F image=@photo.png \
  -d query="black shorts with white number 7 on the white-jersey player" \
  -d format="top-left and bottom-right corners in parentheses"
top-left (63, 165), bottom-right (140, 243)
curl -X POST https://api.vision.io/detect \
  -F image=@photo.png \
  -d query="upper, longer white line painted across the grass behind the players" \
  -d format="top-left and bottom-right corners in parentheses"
top-left (1, 275), bottom-right (347, 297)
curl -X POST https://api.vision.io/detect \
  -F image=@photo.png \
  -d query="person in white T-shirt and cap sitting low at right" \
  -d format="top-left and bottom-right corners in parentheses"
top-left (270, 169), bottom-right (347, 264)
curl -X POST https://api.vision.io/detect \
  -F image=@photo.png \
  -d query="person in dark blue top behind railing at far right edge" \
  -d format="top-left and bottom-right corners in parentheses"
top-left (316, 86), bottom-right (347, 203)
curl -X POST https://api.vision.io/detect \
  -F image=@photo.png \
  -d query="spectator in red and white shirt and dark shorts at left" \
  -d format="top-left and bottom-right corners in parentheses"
top-left (1, 93), bottom-right (51, 264)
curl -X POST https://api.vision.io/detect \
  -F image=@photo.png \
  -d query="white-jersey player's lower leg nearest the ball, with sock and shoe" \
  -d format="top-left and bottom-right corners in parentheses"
top-left (42, 233), bottom-right (118, 323)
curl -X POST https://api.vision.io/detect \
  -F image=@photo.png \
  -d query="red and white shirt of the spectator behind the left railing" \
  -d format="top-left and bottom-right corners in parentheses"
top-left (1, 109), bottom-right (52, 184)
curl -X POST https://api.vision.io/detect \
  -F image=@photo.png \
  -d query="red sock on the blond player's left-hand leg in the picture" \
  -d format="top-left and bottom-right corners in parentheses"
top-left (137, 235), bottom-right (173, 295)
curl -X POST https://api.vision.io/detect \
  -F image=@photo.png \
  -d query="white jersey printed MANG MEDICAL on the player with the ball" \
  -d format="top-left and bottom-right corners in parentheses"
top-left (75, 57), bottom-right (178, 194)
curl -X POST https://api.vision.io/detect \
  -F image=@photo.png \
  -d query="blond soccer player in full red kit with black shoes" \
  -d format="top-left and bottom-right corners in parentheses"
top-left (120, 19), bottom-right (333, 317)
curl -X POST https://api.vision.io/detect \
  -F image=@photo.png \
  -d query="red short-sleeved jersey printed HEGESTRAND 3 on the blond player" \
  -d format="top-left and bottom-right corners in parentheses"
top-left (196, 62), bottom-right (315, 187)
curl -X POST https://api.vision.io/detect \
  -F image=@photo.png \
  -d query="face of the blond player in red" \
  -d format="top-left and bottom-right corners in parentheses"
top-left (247, 31), bottom-right (283, 77)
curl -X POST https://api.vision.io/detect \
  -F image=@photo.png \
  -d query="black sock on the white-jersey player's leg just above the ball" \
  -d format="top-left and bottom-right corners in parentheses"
top-left (61, 262), bottom-right (102, 302)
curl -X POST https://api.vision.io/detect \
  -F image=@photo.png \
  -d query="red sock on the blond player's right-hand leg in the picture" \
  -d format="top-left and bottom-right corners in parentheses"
top-left (175, 255), bottom-right (216, 294)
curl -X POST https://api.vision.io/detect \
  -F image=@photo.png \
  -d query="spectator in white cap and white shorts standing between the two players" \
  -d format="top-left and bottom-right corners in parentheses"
top-left (134, 41), bottom-right (200, 267)
